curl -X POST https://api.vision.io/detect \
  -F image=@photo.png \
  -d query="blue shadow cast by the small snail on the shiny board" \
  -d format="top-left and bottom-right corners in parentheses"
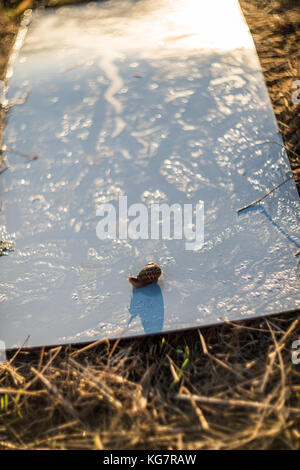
top-left (128, 282), bottom-right (164, 334)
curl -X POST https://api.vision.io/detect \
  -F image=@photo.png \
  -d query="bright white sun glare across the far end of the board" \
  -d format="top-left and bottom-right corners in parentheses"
top-left (26, 0), bottom-right (253, 60)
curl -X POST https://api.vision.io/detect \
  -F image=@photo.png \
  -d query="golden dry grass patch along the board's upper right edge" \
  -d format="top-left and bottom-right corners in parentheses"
top-left (240, 0), bottom-right (300, 192)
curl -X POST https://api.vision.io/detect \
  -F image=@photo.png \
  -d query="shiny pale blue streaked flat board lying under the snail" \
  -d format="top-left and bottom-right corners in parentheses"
top-left (0, 0), bottom-right (300, 347)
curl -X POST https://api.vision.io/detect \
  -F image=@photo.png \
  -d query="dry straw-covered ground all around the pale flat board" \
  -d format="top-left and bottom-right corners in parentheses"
top-left (0, 0), bottom-right (300, 449)
